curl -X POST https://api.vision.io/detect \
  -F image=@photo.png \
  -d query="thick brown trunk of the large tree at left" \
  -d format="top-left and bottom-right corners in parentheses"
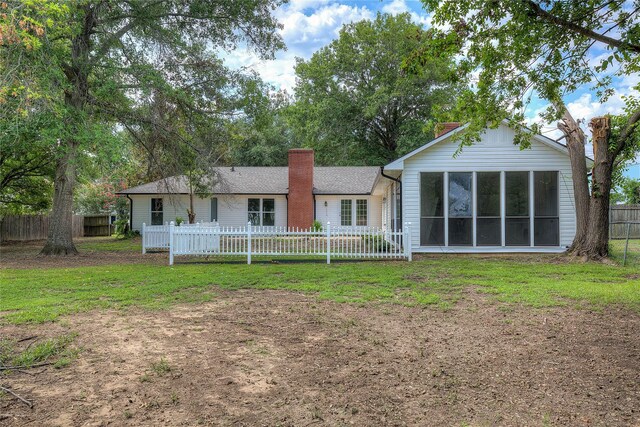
top-left (40, 142), bottom-right (78, 255)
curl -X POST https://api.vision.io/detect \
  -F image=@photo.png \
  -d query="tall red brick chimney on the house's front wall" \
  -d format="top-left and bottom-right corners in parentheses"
top-left (287, 148), bottom-right (313, 228)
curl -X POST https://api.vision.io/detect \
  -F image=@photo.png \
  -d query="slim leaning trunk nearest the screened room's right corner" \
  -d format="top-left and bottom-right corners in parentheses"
top-left (558, 107), bottom-right (590, 254)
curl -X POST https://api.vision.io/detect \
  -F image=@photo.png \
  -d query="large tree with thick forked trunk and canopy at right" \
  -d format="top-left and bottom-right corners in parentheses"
top-left (418, 0), bottom-right (640, 259)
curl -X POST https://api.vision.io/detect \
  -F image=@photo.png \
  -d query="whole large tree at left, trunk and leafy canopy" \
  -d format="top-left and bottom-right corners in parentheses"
top-left (0, 0), bottom-right (283, 254)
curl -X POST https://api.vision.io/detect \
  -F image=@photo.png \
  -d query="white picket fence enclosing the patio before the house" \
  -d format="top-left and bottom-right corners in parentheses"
top-left (142, 222), bottom-right (411, 265)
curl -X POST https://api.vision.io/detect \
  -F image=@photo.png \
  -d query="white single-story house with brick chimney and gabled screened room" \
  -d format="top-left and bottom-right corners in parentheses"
top-left (121, 123), bottom-right (589, 253)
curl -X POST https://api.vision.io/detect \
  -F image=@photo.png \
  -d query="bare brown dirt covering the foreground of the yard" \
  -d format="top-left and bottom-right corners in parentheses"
top-left (0, 290), bottom-right (640, 426)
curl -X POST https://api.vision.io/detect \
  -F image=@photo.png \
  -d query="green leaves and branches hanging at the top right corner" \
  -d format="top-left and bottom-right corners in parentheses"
top-left (416, 0), bottom-right (640, 147)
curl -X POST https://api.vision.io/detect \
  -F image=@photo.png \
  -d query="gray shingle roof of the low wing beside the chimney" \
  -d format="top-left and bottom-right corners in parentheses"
top-left (120, 166), bottom-right (379, 194)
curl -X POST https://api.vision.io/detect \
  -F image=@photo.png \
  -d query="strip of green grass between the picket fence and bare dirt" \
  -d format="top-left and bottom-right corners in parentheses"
top-left (0, 240), bottom-right (640, 323)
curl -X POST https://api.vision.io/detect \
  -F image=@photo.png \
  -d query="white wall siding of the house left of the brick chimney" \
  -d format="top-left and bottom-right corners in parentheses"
top-left (130, 194), bottom-right (287, 230)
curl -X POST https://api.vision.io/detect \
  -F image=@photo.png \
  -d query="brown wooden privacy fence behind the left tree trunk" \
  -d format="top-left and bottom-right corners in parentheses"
top-left (0, 215), bottom-right (84, 242)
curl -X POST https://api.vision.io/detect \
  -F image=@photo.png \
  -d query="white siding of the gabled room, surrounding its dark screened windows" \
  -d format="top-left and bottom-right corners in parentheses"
top-left (402, 125), bottom-right (575, 252)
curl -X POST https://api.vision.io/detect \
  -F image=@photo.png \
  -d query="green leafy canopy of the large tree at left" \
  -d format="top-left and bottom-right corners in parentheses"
top-left (0, 0), bottom-right (283, 247)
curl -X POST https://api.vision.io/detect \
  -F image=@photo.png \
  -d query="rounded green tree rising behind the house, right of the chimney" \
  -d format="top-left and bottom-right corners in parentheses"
top-left (290, 14), bottom-right (456, 165)
